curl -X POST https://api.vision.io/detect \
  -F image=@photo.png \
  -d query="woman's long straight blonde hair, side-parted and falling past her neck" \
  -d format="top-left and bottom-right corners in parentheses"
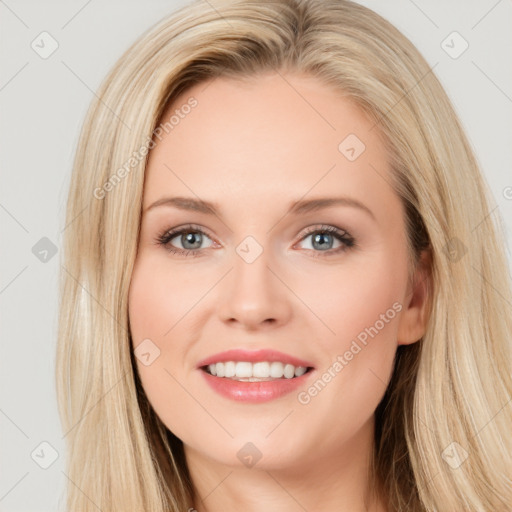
top-left (56, 0), bottom-right (512, 512)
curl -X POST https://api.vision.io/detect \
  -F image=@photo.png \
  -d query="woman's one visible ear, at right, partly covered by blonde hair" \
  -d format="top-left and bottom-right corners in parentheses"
top-left (397, 249), bottom-right (432, 345)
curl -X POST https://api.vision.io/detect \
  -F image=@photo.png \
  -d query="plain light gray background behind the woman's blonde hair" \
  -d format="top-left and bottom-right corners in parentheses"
top-left (0, 0), bottom-right (512, 512)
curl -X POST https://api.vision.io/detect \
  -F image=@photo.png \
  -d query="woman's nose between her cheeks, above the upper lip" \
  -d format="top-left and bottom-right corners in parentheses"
top-left (218, 245), bottom-right (293, 330)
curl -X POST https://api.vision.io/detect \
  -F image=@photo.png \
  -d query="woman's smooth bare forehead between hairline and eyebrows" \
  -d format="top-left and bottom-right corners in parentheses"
top-left (144, 73), bottom-right (393, 216)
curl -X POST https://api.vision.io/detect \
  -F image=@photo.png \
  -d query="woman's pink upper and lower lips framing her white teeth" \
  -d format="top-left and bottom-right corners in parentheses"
top-left (197, 349), bottom-right (313, 403)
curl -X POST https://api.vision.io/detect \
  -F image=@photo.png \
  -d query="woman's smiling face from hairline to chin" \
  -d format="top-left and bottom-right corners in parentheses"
top-left (129, 74), bottom-right (424, 469)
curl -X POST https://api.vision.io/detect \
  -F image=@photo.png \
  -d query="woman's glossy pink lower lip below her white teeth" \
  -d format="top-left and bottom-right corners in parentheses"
top-left (199, 370), bottom-right (313, 403)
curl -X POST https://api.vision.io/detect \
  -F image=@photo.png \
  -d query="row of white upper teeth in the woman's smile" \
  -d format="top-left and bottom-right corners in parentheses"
top-left (207, 361), bottom-right (307, 382)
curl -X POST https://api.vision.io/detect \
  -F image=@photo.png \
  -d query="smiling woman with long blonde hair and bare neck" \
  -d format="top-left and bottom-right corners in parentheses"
top-left (57, 0), bottom-right (512, 512)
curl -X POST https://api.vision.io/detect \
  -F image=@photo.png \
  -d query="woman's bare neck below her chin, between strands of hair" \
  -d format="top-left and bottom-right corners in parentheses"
top-left (185, 419), bottom-right (386, 512)
